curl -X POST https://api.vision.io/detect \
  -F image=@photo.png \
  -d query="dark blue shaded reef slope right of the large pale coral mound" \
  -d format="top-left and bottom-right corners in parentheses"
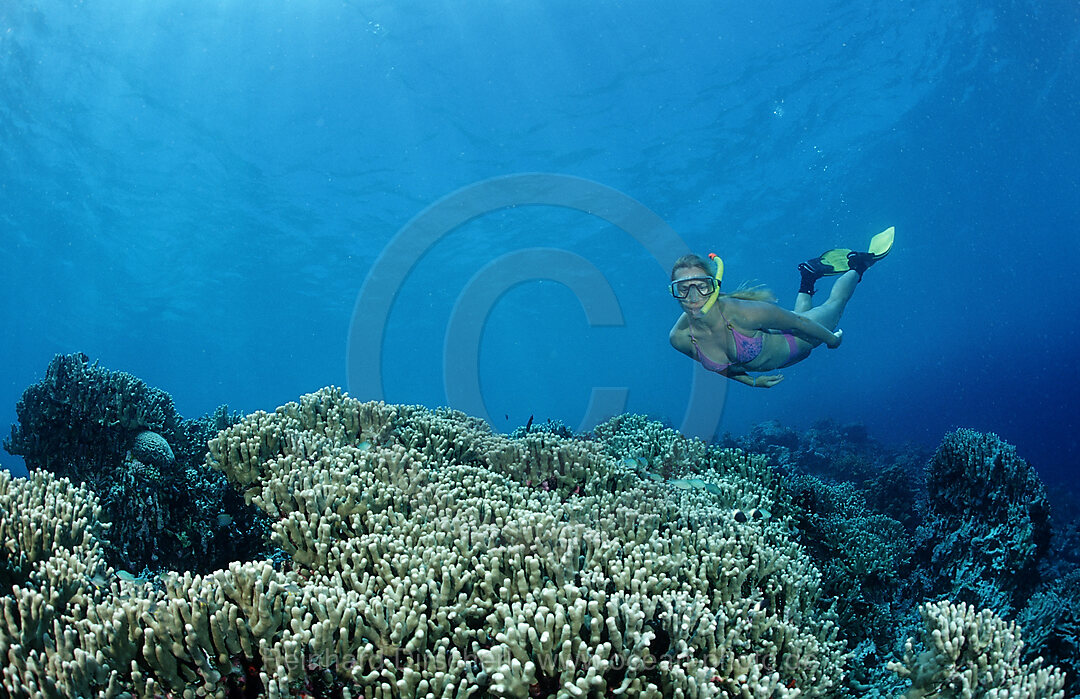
top-left (727, 421), bottom-right (1067, 696)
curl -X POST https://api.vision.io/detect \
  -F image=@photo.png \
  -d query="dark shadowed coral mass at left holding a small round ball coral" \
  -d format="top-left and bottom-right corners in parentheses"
top-left (4, 354), bottom-right (269, 572)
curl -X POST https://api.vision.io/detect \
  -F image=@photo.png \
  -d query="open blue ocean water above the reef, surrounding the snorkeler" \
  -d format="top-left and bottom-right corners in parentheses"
top-left (0, 0), bottom-right (1080, 492)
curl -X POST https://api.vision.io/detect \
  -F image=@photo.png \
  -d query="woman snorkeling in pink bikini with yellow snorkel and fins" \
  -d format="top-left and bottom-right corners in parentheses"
top-left (669, 228), bottom-right (894, 388)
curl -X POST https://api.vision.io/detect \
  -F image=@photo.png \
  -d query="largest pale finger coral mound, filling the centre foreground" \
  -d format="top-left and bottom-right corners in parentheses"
top-left (5, 389), bottom-right (843, 698)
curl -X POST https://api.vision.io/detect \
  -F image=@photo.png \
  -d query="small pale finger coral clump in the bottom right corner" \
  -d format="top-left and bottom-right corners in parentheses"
top-left (889, 602), bottom-right (1065, 699)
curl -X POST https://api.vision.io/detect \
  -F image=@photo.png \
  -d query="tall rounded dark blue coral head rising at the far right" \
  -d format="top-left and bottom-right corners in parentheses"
top-left (916, 430), bottom-right (1051, 616)
